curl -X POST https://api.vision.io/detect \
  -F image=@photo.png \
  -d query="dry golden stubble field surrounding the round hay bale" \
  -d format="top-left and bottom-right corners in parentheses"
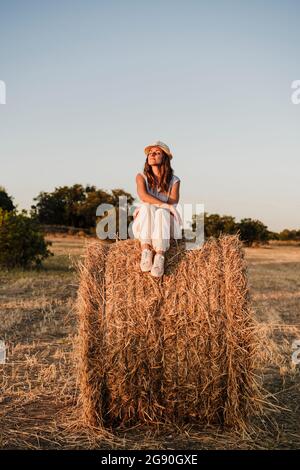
top-left (0, 235), bottom-right (300, 449)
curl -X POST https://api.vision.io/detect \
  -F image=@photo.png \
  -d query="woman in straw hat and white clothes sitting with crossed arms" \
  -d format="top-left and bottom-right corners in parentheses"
top-left (132, 141), bottom-right (182, 277)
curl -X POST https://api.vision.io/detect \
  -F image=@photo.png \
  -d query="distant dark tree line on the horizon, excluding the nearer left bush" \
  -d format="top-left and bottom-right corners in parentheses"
top-left (0, 184), bottom-right (300, 242)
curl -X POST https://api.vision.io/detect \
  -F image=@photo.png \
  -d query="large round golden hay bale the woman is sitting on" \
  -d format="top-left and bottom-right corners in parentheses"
top-left (77, 235), bottom-right (260, 428)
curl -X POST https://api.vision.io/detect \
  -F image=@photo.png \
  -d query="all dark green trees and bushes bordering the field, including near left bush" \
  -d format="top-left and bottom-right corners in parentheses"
top-left (0, 184), bottom-right (300, 267)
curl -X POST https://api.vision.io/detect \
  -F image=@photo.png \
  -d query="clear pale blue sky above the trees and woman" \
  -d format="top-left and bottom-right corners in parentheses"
top-left (0, 0), bottom-right (300, 231)
